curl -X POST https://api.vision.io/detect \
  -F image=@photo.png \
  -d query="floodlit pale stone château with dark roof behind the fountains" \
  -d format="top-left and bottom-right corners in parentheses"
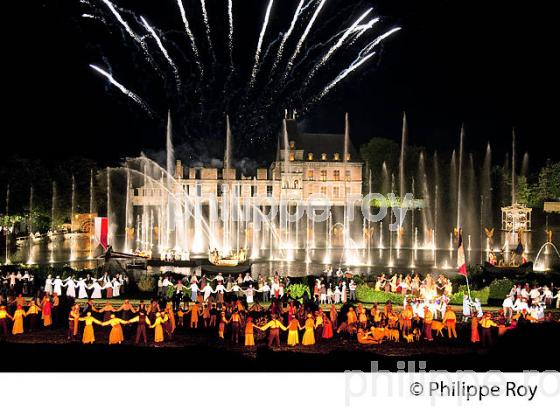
top-left (133, 118), bottom-right (363, 206)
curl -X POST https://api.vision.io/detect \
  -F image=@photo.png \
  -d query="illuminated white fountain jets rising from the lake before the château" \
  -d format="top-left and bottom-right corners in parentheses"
top-left (17, 116), bottom-right (560, 269)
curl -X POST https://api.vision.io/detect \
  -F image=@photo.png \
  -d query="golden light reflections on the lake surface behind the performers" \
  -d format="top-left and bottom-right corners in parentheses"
top-left (10, 229), bottom-right (558, 276)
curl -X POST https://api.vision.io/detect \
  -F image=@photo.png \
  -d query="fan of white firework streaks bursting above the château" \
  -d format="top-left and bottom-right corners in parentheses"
top-left (80, 0), bottom-right (399, 157)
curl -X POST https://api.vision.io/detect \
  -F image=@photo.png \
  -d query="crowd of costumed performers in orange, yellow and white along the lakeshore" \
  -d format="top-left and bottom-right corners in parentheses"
top-left (0, 273), bottom-right (558, 347)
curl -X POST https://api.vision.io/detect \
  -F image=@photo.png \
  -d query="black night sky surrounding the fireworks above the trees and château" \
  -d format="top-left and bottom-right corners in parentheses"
top-left (2, 0), bottom-right (560, 167)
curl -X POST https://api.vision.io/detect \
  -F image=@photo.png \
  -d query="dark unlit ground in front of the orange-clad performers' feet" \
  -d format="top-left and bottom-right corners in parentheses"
top-left (0, 323), bottom-right (560, 372)
